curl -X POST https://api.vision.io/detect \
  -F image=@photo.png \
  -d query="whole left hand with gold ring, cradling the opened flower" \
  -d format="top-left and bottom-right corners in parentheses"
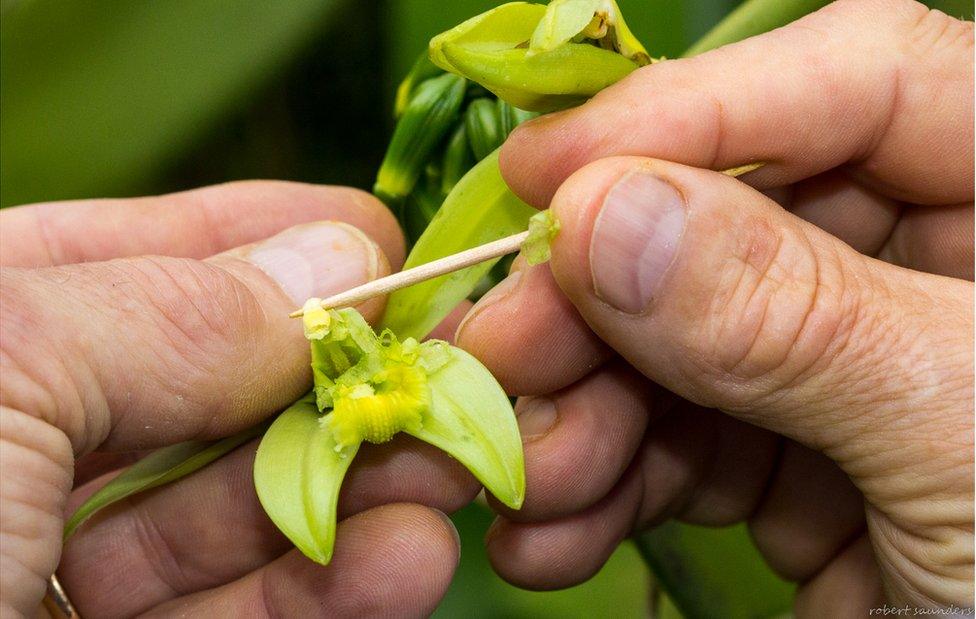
top-left (0, 182), bottom-right (479, 617)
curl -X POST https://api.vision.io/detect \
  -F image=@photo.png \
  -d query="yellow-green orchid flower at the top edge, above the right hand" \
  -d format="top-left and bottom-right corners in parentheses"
top-left (430, 0), bottom-right (651, 112)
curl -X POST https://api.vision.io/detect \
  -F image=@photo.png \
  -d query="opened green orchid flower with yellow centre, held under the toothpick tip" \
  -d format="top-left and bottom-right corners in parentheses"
top-left (254, 299), bottom-right (525, 564)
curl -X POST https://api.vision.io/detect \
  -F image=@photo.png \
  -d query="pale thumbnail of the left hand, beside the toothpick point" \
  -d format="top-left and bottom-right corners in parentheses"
top-left (244, 221), bottom-right (379, 304)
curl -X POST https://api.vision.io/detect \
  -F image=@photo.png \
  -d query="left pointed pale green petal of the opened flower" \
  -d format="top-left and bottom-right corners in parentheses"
top-left (254, 395), bottom-right (359, 565)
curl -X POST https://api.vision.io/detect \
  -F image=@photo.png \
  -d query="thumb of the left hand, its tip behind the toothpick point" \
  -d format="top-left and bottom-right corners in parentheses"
top-left (0, 223), bottom-right (389, 454)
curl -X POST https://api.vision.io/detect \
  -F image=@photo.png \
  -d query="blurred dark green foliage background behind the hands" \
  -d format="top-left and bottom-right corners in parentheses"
top-left (0, 0), bottom-right (973, 618)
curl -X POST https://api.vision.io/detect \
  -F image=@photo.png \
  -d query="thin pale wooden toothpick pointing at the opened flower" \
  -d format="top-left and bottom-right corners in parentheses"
top-left (289, 230), bottom-right (529, 318)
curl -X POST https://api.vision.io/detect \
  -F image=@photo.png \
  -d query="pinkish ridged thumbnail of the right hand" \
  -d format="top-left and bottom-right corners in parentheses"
top-left (590, 170), bottom-right (686, 314)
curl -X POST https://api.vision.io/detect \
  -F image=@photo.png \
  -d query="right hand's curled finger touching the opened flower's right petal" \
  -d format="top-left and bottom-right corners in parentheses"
top-left (491, 363), bottom-right (659, 522)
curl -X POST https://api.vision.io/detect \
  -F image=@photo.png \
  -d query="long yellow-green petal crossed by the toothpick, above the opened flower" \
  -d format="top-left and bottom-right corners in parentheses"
top-left (381, 151), bottom-right (538, 340)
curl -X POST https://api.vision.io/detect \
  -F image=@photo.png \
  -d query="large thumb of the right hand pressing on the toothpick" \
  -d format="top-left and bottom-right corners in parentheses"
top-left (552, 157), bottom-right (973, 480)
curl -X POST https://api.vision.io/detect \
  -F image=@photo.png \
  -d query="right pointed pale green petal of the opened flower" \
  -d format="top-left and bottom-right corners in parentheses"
top-left (406, 343), bottom-right (525, 509)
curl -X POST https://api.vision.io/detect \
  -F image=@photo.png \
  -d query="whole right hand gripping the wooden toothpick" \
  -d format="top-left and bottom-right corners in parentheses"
top-left (458, 1), bottom-right (973, 617)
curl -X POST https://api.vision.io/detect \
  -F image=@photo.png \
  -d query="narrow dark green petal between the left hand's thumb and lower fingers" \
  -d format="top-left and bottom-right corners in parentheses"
top-left (64, 423), bottom-right (268, 541)
